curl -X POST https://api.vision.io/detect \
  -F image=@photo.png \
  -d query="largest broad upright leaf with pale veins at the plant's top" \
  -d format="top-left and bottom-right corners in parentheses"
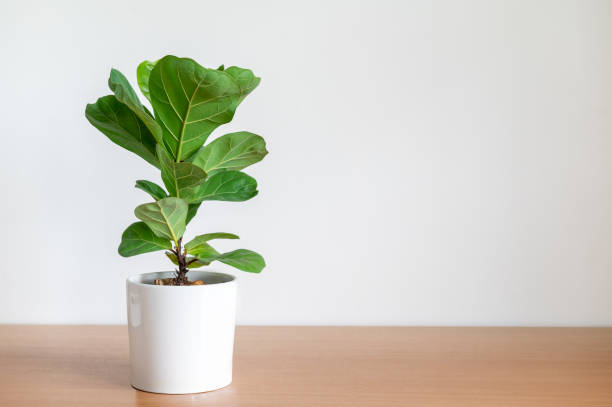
top-left (149, 55), bottom-right (259, 162)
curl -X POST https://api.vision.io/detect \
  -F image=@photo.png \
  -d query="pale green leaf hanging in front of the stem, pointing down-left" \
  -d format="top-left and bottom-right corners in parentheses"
top-left (134, 197), bottom-right (187, 243)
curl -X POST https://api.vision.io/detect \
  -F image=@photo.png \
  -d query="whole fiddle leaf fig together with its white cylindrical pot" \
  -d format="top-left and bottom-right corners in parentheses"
top-left (85, 55), bottom-right (267, 394)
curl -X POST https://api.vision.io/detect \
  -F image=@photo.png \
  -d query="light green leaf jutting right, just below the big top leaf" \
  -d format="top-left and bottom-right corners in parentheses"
top-left (191, 131), bottom-right (268, 176)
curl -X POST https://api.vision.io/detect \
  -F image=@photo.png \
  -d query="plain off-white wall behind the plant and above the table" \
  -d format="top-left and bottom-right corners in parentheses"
top-left (0, 0), bottom-right (612, 325)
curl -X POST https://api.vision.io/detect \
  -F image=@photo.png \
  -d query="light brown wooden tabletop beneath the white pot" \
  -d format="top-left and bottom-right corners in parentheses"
top-left (0, 325), bottom-right (612, 407)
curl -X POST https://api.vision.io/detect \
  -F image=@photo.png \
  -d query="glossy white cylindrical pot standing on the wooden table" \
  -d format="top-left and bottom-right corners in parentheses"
top-left (126, 271), bottom-right (236, 394)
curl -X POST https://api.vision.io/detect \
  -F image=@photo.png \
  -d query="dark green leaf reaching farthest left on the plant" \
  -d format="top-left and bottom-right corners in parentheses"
top-left (85, 95), bottom-right (159, 168)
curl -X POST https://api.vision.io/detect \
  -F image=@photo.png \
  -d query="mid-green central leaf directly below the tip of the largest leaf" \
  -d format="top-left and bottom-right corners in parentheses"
top-left (157, 144), bottom-right (206, 203)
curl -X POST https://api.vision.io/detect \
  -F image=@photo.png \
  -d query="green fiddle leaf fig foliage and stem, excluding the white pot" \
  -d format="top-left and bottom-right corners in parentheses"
top-left (85, 55), bottom-right (268, 285)
